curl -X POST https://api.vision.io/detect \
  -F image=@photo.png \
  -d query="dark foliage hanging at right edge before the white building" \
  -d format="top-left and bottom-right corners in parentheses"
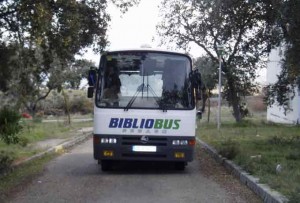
top-left (266, 0), bottom-right (300, 111)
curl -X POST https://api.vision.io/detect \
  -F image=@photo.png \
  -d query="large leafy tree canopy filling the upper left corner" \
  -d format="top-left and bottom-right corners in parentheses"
top-left (0, 0), bottom-right (138, 114)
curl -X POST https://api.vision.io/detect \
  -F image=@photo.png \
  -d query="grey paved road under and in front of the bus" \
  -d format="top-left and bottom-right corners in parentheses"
top-left (10, 140), bottom-right (257, 203)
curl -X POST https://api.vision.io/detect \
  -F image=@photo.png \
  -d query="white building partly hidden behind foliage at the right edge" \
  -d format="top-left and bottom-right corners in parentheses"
top-left (267, 47), bottom-right (300, 124)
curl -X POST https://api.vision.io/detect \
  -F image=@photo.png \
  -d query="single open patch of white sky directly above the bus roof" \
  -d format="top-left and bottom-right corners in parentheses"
top-left (108, 0), bottom-right (160, 49)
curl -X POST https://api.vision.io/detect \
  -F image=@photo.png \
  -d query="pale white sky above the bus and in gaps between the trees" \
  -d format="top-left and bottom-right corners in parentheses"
top-left (84, 0), bottom-right (266, 83)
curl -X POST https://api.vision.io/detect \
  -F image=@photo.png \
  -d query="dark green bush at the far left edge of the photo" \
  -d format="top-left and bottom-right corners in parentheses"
top-left (0, 107), bottom-right (22, 144)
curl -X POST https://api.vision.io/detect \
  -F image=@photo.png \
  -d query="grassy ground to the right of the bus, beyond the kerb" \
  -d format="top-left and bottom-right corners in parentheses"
top-left (197, 108), bottom-right (300, 201)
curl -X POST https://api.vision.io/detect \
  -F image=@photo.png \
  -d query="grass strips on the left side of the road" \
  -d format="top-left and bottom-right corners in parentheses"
top-left (0, 116), bottom-right (92, 202)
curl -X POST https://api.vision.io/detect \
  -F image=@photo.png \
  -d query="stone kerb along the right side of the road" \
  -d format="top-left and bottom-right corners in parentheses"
top-left (196, 137), bottom-right (288, 203)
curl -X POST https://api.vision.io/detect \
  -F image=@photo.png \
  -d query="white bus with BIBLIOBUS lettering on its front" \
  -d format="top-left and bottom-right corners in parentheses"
top-left (88, 49), bottom-right (199, 171)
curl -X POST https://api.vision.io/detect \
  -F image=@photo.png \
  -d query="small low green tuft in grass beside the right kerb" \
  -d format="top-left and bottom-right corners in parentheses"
top-left (219, 140), bottom-right (240, 160)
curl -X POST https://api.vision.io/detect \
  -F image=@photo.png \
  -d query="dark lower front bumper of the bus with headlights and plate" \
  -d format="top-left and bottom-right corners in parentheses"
top-left (93, 135), bottom-right (195, 162)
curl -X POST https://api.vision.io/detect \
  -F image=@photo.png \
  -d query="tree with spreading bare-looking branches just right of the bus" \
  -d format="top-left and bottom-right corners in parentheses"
top-left (157, 0), bottom-right (277, 122)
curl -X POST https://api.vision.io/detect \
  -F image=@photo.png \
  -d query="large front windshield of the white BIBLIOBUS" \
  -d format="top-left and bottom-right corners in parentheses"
top-left (96, 51), bottom-right (194, 110)
